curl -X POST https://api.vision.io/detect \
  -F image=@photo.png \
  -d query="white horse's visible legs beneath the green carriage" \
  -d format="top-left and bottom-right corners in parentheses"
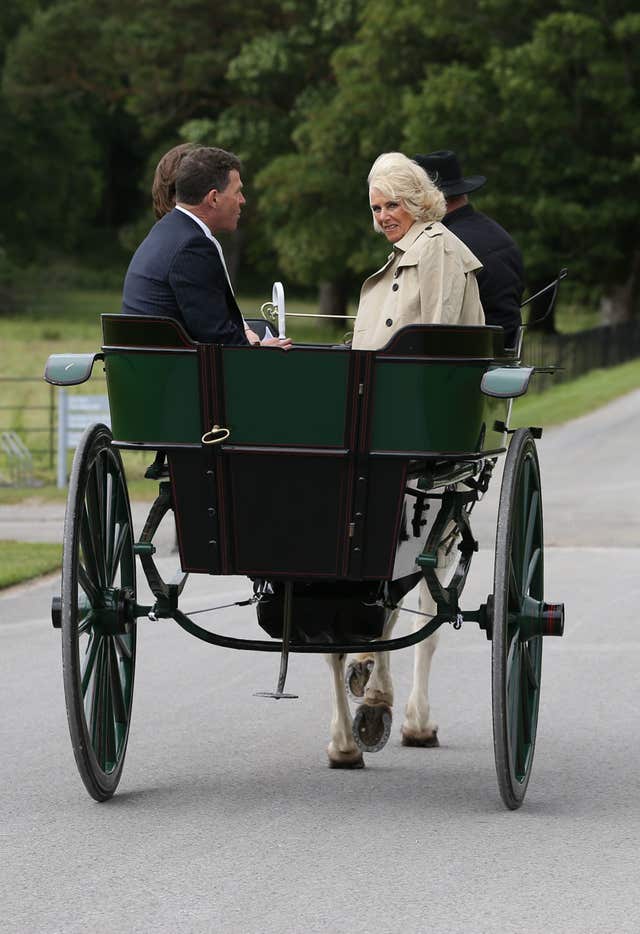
top-left (326, 533), bottom-right (458, 769)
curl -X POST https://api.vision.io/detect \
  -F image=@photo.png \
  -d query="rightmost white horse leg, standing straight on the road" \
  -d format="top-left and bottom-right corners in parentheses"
top-left (401, 581), bottom-right (440, 746)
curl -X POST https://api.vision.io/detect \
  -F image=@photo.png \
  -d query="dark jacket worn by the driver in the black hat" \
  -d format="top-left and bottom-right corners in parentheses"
top-left (442, 204), bottom-right (524, 347)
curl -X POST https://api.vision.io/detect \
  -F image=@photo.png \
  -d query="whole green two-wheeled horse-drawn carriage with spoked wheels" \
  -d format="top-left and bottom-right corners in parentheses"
top-left (45, 306), bottom-right (564, 808)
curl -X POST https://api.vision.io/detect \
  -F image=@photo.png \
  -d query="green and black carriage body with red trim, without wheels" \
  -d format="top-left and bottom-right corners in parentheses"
top-left (95, 315), bottom-right (509, 580)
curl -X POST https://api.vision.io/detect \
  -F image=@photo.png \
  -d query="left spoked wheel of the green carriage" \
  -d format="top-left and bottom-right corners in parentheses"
top-left (61, 425), bottom-right (136, 801)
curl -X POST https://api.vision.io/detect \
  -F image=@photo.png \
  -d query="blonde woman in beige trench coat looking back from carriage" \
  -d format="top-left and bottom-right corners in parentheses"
top-left (352, 152), bottom-right (484, 350)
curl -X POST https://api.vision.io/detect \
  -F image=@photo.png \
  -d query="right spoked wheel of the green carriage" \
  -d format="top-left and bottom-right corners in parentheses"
top-left (490, 429), bottom-right (544, 809)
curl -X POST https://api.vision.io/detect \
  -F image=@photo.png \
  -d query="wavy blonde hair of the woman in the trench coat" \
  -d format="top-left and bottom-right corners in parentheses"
top-left (367, 152), bottom-right (447, 233)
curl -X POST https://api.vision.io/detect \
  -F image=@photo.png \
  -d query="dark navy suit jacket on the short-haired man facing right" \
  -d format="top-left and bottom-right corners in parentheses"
top-left (122, 208), bottom-right (248, 344)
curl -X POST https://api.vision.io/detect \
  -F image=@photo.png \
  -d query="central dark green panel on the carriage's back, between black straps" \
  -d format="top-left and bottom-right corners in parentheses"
top-left (223, 347), bottom-right (350, 447)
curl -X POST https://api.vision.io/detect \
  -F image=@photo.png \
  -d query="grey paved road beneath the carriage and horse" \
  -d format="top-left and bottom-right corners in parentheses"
top-left (0, 392), bottom-right (640, 934)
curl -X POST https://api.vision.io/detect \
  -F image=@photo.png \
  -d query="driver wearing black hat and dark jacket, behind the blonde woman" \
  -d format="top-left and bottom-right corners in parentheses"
top-left (413, 149), bottom-right (524, 347)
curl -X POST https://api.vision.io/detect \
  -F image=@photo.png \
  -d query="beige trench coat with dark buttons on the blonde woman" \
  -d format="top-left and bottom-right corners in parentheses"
top-left (352, 221), bottom-right (484, 350)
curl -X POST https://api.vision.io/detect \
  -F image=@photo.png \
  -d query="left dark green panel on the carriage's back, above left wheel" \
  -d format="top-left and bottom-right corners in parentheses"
top-left (105, 350), bottom-right (203, 445)
